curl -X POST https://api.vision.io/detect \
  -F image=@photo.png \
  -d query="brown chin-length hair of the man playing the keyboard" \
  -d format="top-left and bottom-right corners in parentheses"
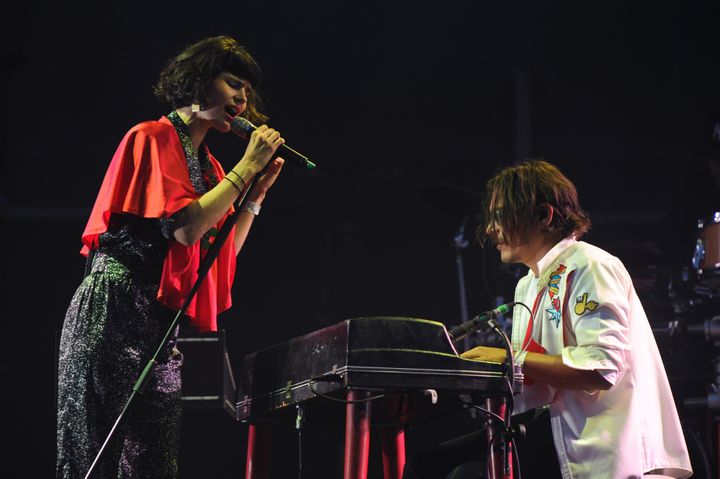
top-left (476, 158), bottom-right (590, 245)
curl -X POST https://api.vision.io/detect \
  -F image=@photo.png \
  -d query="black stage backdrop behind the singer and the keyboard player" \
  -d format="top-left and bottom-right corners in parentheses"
top-left (0, 0), bottom-right (720, 478)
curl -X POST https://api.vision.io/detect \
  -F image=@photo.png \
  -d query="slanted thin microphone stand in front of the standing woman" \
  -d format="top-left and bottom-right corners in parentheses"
top-left (85, 173), bottom-right (261, 479)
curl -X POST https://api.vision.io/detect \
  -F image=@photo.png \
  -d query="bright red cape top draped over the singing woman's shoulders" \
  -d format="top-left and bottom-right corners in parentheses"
top-left (80, 117), bottom-right (235, 331)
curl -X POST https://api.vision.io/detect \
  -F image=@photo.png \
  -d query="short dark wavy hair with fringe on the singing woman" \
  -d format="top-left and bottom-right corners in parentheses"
top-left (153, 35), bottom-right (268, 124)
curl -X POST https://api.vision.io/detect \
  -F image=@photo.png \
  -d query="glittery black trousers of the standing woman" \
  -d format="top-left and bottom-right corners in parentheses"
top-left (56, 254), bottom-right (182, 479)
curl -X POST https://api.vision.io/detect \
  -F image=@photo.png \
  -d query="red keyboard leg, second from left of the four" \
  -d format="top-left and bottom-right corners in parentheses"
top-left (344, 389), bottom-right (371, 479)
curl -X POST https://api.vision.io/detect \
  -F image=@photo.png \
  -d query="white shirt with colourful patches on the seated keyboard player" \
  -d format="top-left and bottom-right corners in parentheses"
top-left (512, 238), bottom-right (692, 479)
